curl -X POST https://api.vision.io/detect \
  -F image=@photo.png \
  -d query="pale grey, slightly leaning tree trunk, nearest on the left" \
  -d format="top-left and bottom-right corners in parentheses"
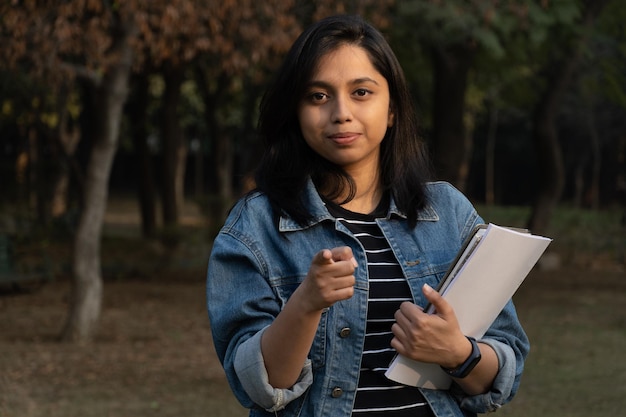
top-left (61, 21), bottom-right (133, 343)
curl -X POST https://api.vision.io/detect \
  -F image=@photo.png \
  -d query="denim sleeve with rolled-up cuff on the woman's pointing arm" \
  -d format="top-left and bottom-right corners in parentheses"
top-left (207, 230), bottom-right (313, 412)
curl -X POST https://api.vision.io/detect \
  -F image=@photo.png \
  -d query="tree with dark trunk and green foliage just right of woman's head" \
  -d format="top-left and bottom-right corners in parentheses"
top-left (394, 0), bottom-right (588, 190)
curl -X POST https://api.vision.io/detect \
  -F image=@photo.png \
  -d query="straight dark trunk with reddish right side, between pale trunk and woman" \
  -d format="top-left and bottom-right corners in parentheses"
top-left (161, 66), bottom-right (187, 228)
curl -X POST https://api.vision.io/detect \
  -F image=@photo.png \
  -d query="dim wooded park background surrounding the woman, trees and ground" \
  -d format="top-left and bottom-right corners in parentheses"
top-left (0, 0), bottom-right (626, 417)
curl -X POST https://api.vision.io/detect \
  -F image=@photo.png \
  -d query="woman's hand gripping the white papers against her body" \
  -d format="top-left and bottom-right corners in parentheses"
top-left (391, 285), bottom-right (472, 368)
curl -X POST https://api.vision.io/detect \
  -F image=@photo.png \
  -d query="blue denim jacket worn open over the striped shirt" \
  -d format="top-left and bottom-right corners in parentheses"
top-left (207, 181), bottom-right (529, 417)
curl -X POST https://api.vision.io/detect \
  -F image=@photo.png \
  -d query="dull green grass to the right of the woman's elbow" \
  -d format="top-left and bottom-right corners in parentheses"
top-left (498, 269), bottom-right (626, 417)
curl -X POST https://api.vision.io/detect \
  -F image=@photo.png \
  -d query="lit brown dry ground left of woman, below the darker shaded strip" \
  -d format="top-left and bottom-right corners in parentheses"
top-left (0, 274), bottom-right (249, 417)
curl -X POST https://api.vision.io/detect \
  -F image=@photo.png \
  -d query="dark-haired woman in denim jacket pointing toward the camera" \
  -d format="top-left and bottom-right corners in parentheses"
top-left (207, 16), bottom-right (529, 417)
